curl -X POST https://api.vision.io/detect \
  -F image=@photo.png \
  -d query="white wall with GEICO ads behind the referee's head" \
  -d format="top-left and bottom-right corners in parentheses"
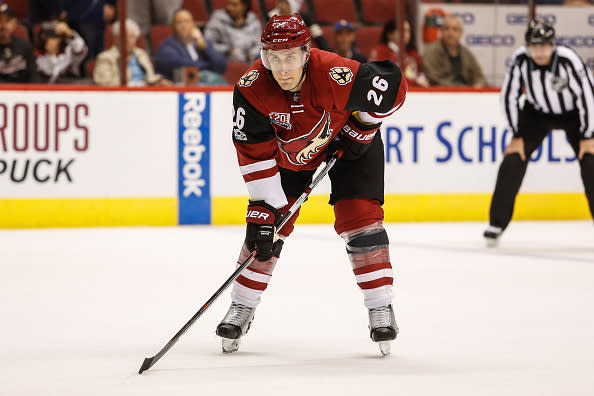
top-left (417, 3), bottom-right (594, 86)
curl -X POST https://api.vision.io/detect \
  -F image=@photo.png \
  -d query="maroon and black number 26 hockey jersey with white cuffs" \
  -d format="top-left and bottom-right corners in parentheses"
top-left (233, 49), bottom-right (407, 208)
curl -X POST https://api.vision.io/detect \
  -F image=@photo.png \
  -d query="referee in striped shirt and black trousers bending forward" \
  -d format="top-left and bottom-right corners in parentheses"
top-left (483, 20), bottom-right (594, 247)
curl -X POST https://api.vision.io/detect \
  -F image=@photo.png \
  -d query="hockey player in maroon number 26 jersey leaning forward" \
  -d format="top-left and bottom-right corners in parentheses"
top-left (216, 14), bottom-right (407, 355)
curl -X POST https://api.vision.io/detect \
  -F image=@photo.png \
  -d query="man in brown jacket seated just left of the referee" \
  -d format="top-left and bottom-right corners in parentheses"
top-left (423, 15), bottom-right (487, 88)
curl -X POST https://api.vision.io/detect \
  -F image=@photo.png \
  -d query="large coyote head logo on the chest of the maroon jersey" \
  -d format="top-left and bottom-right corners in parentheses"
top-left (278, 111), bottom-right (332, 165)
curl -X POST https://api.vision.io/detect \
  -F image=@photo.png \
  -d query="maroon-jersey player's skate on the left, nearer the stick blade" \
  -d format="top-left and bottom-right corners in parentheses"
top-left (217, 303), bottom-right (256, 353)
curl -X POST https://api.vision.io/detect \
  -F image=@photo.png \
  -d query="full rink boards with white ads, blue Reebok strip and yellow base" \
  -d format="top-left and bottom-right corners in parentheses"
top-left (0, 86), bottom-right (589, 228)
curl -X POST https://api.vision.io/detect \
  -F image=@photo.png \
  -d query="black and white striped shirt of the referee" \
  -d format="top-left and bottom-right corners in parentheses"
top-left (501, 45), bottom-right (594, 138)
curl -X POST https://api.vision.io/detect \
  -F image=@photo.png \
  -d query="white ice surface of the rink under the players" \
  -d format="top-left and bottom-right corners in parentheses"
top-left (0, 221), bottom-right (594, 396)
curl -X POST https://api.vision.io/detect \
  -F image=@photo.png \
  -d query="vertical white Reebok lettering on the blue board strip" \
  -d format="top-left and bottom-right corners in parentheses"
top-left (181, 92), bottom-right (206, 198)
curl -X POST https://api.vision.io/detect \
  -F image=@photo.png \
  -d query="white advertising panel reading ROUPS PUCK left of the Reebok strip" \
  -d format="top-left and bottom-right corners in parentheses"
top-left (0, 91), bottom-right (178, 198)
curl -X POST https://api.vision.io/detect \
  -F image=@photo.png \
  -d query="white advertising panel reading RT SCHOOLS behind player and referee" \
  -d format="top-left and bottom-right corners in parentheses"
top-left (211, 92), bottom-right (583, 197)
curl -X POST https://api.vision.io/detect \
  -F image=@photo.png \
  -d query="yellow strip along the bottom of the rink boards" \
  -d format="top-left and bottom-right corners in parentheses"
top-left (0, 193), bottom-right (591, 228)
